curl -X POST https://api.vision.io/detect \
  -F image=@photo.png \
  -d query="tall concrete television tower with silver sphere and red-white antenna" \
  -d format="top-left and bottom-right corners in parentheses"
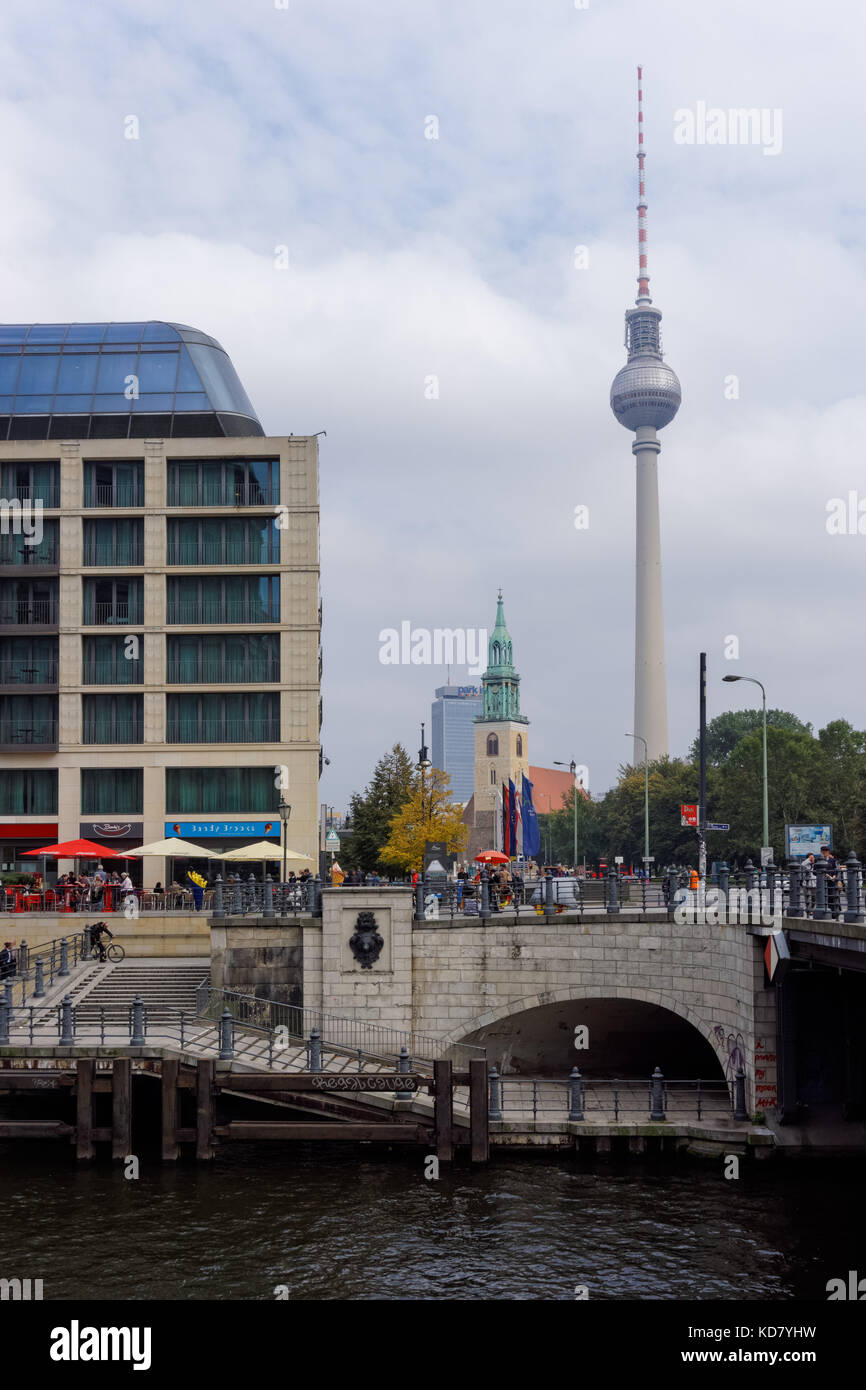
top-left (610, 68), bottom-right (681, 766)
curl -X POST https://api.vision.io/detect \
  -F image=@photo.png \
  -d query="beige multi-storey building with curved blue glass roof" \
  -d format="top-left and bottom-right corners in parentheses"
top-left (0, 322), bottom-right (321, 883)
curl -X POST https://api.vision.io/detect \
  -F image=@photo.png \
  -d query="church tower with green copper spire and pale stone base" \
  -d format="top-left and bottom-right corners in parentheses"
top-left (468, 589), bottom-right (530, 855)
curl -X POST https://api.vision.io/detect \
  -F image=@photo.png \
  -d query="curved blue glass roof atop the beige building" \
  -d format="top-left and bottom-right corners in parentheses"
top-left (0, 320), bottom-right (264, 439)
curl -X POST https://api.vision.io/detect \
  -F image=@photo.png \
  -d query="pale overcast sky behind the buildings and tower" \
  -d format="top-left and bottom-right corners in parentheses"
top-left (0, 0), bottom-right (866, 809)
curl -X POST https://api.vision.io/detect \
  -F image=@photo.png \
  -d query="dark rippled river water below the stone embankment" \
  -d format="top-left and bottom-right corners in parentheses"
top-left (0, 1143), bottom-right (866, 1300)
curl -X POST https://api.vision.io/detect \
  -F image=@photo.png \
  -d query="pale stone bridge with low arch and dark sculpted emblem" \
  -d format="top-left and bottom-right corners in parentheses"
top-left (211, 887), bottom-right (776, 1109)
